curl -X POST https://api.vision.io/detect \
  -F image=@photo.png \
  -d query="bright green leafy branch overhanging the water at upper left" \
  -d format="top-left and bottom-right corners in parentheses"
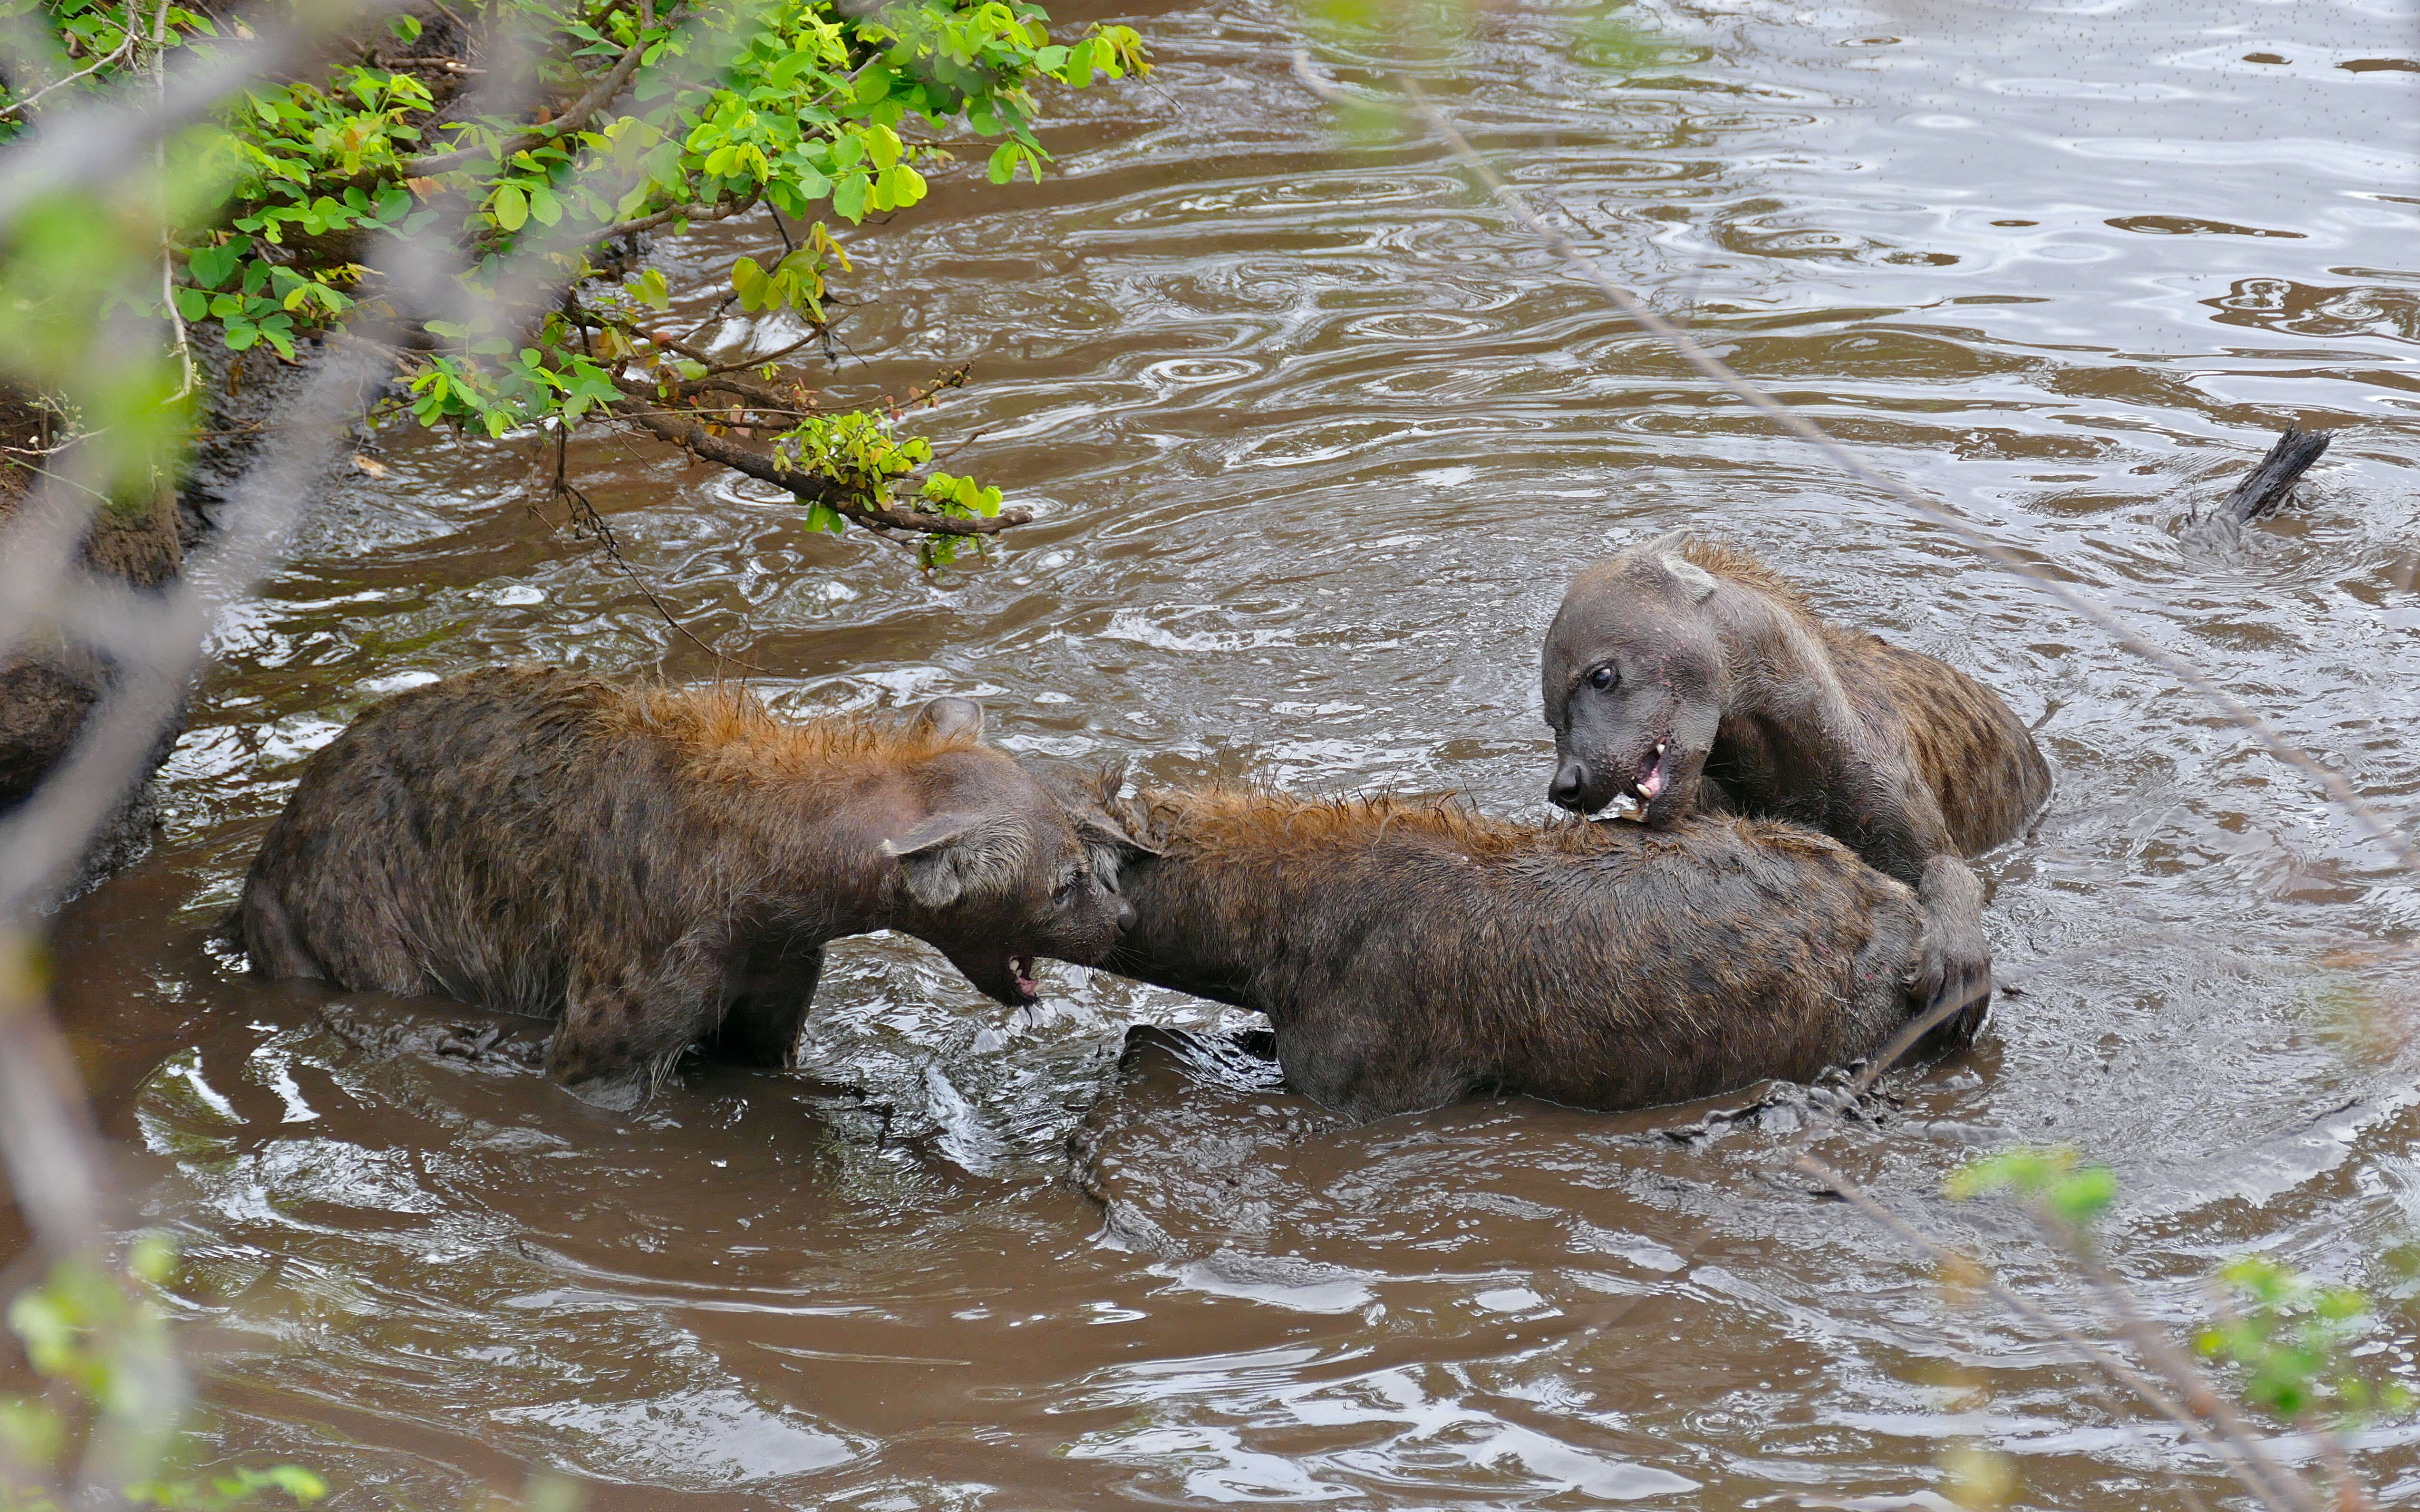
top-left (0, 0), bottom-right (1150, 566)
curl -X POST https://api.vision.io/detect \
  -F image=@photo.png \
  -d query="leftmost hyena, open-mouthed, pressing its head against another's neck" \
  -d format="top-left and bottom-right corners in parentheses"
top-left (235, 668), bottom-right (1133, 1110)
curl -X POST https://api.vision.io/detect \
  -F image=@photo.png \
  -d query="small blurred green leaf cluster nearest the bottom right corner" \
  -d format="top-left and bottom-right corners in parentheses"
top-left (2193, 1256), bottom-right (2415, 1432)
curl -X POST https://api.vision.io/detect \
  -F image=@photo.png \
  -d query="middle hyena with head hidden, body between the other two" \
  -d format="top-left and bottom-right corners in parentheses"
top-left (1053, 772), bottom-right (1921, 1117)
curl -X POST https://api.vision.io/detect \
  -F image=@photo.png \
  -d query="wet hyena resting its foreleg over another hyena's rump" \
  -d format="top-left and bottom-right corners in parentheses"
top-left (1539, 525), bottom-right (2050, 1028)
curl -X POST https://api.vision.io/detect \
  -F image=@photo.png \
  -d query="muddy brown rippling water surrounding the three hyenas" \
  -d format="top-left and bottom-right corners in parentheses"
top-left (19, 0), bottom-right (2420, 1507)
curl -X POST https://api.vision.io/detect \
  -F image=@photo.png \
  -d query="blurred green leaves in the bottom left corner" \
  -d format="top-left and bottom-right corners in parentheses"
top-left (0, 1234), bottom-right (327, 1512)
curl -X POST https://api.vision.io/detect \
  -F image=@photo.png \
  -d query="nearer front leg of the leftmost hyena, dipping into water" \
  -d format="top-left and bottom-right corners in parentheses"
top-left (547, 939), bottom-right (726, 1113)
